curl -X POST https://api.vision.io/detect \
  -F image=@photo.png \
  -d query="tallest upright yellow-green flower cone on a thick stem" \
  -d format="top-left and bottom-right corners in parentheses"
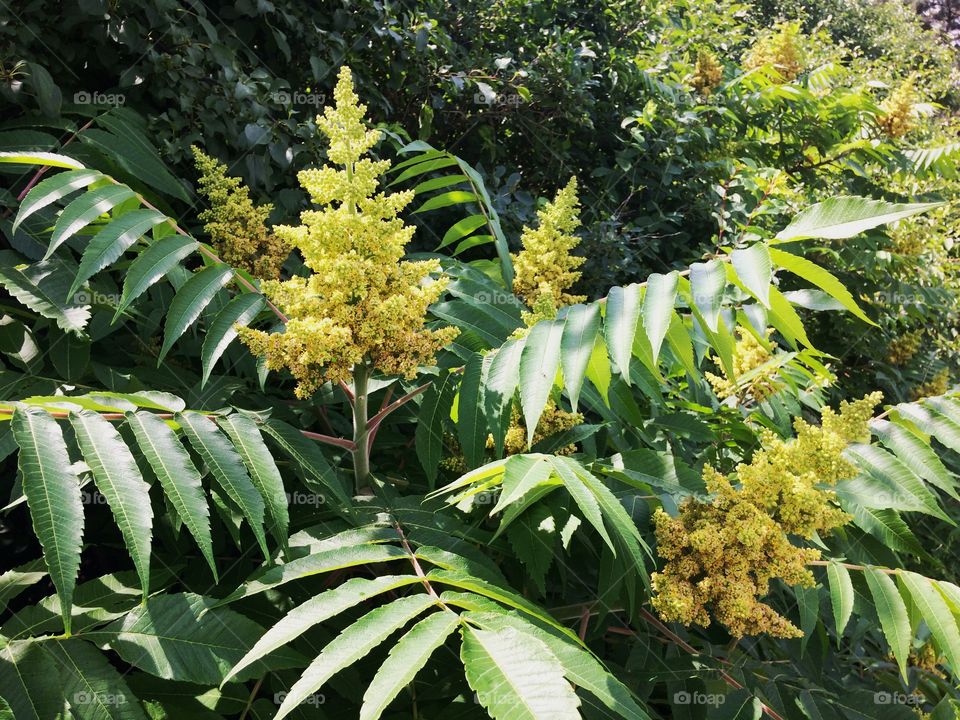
top-left (240, 67), bottom-right (458, 397)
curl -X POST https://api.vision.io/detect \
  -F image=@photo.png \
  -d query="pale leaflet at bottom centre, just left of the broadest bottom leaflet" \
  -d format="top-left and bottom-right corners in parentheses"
top-left (360, 610), bottom-right (460, 720)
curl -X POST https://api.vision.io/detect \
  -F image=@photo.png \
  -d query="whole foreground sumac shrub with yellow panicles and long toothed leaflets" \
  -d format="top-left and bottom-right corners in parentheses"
top-left (0, 69), bottom-right (960, 720)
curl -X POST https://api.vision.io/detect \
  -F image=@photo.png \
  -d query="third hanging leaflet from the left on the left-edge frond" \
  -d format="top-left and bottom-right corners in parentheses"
top-left (126, 412), bottom-right (217, 578)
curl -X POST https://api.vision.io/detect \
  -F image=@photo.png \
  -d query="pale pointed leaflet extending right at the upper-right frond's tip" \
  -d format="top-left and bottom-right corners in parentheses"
top-left (776, 195), bottom-right (943, 242)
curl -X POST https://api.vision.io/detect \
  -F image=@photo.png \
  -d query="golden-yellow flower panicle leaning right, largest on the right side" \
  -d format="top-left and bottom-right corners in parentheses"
top-left (652, 393), bottom-right (880, 638)
